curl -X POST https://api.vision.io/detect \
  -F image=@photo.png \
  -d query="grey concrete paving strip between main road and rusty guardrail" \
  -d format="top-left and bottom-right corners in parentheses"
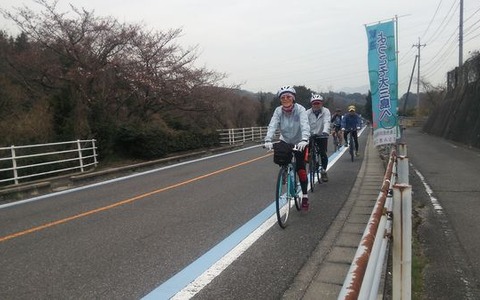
top-left (283, 135), bottom-right (385, 299)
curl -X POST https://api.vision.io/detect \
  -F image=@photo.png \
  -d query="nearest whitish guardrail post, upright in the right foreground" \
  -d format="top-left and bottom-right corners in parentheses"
top-left (392, 183), bottom-right (412, 300)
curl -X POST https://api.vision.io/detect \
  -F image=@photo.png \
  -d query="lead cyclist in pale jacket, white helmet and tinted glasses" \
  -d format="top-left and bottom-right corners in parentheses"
top-left (265, 86), bottom-right (310, 211)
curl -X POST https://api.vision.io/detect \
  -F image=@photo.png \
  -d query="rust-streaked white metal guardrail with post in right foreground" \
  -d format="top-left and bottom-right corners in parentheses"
top-left (338, 144), bottom-right (412, 300)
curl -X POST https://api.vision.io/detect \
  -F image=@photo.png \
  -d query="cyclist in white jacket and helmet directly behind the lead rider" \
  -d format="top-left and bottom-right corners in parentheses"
top-left (307, 94), bottom-right (330, 184)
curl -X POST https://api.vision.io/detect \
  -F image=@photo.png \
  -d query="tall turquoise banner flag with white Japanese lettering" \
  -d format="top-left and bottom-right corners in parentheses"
top-left (366, 21), bottom-right (398, 146)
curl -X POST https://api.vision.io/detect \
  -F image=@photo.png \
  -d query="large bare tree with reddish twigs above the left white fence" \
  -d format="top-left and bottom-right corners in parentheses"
top-left (1, 0), bottom-right (232, 152)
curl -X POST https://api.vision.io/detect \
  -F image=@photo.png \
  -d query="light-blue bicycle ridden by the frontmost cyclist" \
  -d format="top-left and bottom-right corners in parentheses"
top-left (275, 145), bottom-right (302, 228)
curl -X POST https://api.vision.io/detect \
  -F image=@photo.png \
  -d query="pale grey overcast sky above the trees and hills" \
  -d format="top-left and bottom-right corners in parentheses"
top-left (0, 0), bottom-right (480, 95)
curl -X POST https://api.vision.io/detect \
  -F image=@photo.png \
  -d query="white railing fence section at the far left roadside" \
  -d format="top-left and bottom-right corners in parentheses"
top-left (0, 139), bottom-right (98, 185)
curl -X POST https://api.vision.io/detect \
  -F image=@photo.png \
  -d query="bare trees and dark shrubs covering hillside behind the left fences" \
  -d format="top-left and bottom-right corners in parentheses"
top-left (0, 0), bottom-right (372, 159)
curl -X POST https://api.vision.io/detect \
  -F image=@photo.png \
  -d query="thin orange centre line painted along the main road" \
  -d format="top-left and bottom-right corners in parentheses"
top-left (0, 153), bottom-right (272, 243)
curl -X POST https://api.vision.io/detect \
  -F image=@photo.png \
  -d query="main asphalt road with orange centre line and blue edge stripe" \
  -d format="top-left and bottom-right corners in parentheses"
top-left (0, 134), bottom-right (368, 299)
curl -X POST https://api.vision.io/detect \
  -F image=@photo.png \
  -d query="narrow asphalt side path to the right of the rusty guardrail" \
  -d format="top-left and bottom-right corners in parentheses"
top-left (405, 128), bottom-right (480, 299)
